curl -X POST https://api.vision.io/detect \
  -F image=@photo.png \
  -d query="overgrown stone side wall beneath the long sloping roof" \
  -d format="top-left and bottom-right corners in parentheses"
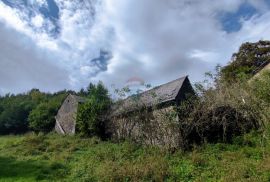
top-left (109, 106), bottom-right (182, 148)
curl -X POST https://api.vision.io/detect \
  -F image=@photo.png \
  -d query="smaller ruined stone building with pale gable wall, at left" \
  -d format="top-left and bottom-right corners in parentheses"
top-left (55, 94), bottom-right (86, 135)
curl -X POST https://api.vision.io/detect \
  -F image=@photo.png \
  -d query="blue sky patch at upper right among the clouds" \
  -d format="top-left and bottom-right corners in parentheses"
top-left (218, 3), bottom-right (259, 33)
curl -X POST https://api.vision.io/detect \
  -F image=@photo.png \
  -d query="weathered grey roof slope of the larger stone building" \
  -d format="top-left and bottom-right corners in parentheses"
top-left (112, 76), bottom-right (188, 116)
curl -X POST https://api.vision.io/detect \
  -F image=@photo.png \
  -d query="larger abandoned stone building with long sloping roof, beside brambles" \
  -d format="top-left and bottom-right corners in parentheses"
top-left (108, 76), bottom-right (195, 148)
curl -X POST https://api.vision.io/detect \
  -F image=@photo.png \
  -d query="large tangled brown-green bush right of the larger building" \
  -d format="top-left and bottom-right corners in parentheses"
top-left (179, 70), bottom-right (270, 149)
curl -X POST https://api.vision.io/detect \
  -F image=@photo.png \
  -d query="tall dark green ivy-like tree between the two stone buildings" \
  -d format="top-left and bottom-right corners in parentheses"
top-left (76, 82), bottom-right (111, 137)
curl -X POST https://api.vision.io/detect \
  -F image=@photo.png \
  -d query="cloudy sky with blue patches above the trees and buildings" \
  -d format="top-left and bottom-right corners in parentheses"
top-left (0, 0), bottom-right (270, 94)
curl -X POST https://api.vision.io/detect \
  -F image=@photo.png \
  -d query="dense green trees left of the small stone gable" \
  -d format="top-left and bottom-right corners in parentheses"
top-left (0, 89), bottom-right (70, 134)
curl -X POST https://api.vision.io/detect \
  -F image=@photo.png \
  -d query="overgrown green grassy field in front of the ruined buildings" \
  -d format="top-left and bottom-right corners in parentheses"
top-left (0, 133), bottom-right (270, 182)
